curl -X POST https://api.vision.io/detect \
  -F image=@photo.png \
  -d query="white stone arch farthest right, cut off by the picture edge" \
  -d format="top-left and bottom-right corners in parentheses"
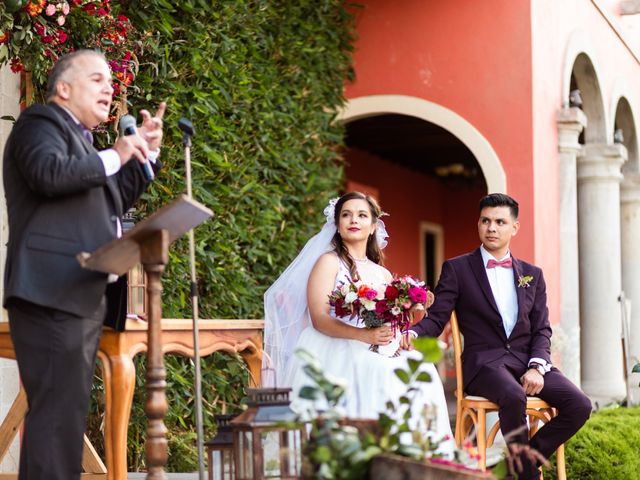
top-left (609, 77), bottom-right (640, 173)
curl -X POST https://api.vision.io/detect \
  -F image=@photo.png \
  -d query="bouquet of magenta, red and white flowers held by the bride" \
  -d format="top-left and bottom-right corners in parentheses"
top-left (329, 275), bottom-right (434, 355)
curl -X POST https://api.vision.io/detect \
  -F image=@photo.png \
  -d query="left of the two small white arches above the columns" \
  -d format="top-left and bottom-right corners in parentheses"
top-left (562, 30), bottom-right (613, 143)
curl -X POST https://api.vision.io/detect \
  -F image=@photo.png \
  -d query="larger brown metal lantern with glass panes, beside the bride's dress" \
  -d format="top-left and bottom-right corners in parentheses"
top-left (231, 388), bottom-right (305, 480)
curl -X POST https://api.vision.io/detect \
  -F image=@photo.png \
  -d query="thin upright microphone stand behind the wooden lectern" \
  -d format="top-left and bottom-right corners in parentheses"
top-left (178, 118), bottom-right (205, 480)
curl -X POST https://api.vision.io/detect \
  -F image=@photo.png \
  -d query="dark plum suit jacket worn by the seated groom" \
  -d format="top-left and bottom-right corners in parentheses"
top-left (413, 248), bottom-right (551, 386)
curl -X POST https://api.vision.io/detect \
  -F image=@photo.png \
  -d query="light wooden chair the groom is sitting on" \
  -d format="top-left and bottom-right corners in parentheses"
top-left (450, 313), bottom-right (567, 480)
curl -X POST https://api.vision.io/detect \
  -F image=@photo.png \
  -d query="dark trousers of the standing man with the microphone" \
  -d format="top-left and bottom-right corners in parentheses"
top-left (7, 299), bottom-right (105, 480)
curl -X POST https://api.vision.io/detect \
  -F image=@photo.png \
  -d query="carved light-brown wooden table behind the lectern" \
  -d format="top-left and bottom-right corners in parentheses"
top-left (0, 319), bottom-right (264, 480)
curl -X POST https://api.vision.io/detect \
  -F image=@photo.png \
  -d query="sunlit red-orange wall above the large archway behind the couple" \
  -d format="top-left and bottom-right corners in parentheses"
top-left (346, 0), bottom-right (534, 260)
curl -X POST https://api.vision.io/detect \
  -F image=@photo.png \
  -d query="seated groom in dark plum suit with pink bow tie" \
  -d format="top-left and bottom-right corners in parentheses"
top-left (412, 193), bottom-right (591, 479)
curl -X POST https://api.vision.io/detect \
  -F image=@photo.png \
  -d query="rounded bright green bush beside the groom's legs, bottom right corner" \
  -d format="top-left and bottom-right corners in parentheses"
top-left (544, 407), bottom-right (640, 480)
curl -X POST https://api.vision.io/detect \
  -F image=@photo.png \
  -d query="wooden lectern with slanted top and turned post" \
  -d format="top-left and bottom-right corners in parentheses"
top-left (78, 195), bottom-right (213, 480)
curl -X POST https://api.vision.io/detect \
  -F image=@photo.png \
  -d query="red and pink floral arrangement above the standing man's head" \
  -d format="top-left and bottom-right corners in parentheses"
top-left (0, 0), bottom-right (142, 120)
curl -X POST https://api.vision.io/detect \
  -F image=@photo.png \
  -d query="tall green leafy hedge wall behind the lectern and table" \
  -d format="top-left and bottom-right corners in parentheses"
top-left (85, 0), bottom-right (353, 471)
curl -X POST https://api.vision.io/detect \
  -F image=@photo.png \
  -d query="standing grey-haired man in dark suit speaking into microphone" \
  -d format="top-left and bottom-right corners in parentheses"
top-left (3, 50), bottom-right (165, 480)
